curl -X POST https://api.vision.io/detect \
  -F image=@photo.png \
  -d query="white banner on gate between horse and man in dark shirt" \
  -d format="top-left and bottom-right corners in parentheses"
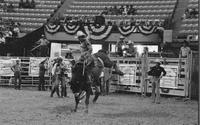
top-left (119, 64), bottom-right (137, 85)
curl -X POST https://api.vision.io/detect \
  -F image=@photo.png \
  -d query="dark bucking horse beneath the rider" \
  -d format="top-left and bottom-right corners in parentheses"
top-left (70, 59), bottom-right (103, 113)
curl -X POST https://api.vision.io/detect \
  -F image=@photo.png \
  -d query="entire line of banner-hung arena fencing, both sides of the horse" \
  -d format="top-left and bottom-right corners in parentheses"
top-left (0, 53), bottom-right (198, 98)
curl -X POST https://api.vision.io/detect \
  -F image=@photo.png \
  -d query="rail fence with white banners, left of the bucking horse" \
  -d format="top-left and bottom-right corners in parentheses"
top-left (0, 57), bottom-right (71, 87)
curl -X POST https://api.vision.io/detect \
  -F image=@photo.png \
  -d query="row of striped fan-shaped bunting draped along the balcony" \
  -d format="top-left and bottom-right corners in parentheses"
top-left (45, 23), bottom-right (163, 40)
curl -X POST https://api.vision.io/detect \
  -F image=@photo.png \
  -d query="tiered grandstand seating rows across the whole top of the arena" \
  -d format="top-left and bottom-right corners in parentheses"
top-left (0, 0), bottom-right (198, 42)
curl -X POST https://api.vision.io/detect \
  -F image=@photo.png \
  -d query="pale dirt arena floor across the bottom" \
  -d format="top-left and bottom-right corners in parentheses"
top-left (0, 88), bottom-right (198, 125)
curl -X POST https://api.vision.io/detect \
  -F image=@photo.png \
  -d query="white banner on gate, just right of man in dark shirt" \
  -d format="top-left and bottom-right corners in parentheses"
top-left (160, 65), bottom-right (178, 88)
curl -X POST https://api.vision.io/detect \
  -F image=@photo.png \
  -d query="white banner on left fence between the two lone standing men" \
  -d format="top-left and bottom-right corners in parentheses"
top-left (29, 57), bottom-right (48, 76)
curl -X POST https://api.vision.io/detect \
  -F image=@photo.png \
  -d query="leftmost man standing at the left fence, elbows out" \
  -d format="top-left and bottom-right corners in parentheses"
top-left (11, 60), bottom-right (22, 90)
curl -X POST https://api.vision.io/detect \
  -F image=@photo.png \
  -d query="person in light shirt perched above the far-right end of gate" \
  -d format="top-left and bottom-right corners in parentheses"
top-left (179, 41), bottom-right (191, 58)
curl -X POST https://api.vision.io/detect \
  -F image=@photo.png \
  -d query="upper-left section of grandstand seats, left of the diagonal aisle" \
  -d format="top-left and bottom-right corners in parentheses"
top-left (0, 0), bottom-right (61, 33)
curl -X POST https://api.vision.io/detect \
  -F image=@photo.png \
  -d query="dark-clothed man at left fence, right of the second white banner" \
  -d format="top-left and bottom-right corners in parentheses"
top-left (38, 59), bottom-right (47, 91)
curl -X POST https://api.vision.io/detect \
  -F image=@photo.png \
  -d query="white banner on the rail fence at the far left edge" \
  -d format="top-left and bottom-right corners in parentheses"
top-left (0, 57), bottom-right (17, 76)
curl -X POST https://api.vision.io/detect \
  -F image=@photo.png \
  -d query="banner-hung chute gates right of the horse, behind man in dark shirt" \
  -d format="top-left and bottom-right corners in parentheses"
top-left (110, 52), bottom-right (197, 98)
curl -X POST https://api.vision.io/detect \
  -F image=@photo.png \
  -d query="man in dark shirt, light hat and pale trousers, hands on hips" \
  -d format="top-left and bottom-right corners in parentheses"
top-left (148, 59), bottom-right (166, 104)
